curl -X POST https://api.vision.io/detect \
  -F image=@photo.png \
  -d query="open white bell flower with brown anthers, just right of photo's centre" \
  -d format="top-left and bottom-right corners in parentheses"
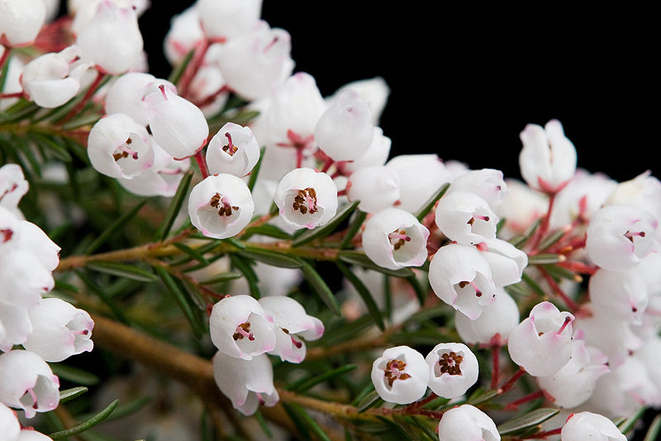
top-left (362, 208), bottom-right (429, 269)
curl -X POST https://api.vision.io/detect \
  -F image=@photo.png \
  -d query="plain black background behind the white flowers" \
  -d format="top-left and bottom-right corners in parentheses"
top-left (140, 0), bottom-right (660, 184)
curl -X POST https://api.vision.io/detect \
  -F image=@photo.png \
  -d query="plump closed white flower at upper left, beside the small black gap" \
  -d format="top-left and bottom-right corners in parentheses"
top-left (76, 0), bottom-right (144, 75)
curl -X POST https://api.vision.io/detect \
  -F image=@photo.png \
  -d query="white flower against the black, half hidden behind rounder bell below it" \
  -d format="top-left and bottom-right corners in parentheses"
top-left (448, 168), bottom-right (507, 211)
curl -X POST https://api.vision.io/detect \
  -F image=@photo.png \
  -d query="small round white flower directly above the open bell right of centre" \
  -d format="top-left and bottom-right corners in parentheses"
top-left (346, 165), bottom-right (399, 213)
